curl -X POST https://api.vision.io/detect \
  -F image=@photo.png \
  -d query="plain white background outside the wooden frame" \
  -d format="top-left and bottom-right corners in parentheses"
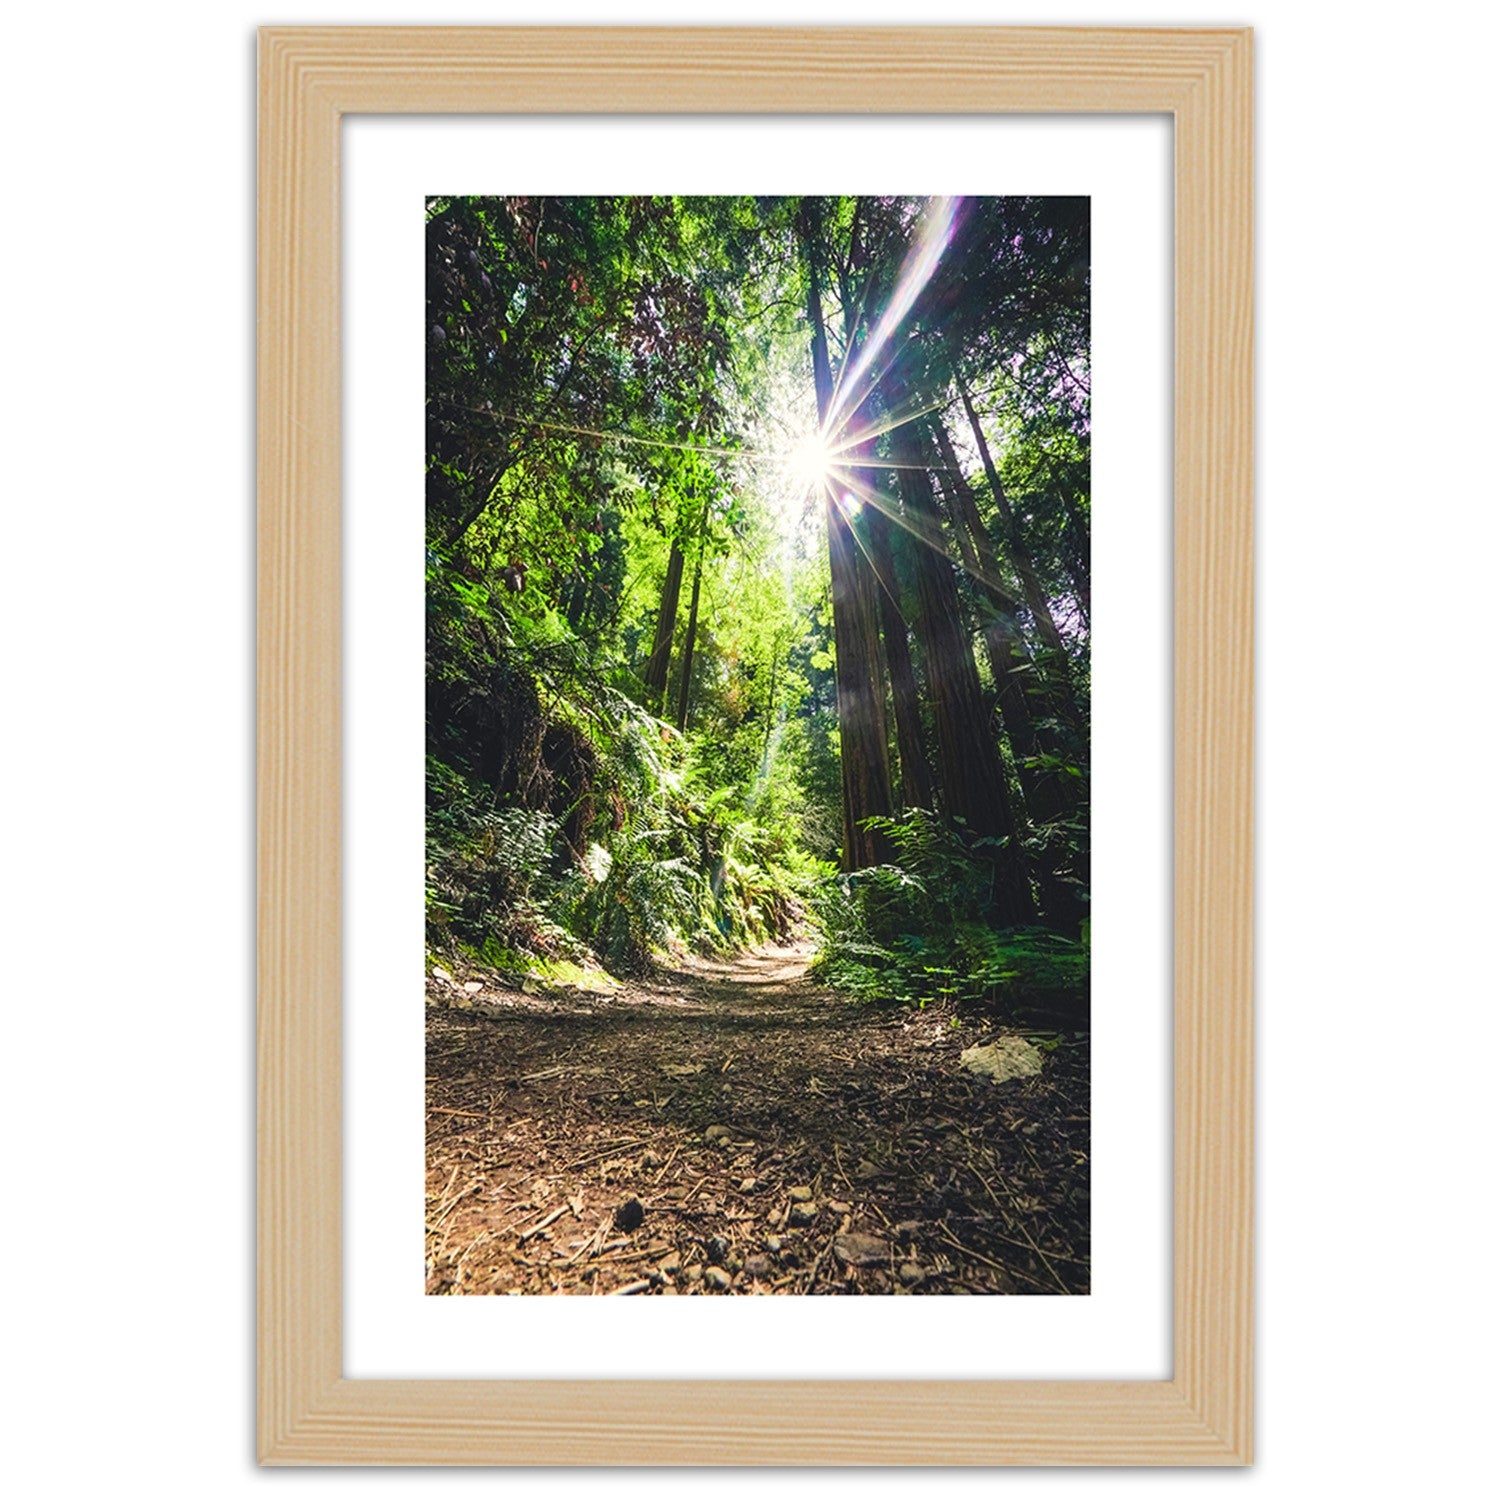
top-left (0, 0), bottom-right (1497, 1497)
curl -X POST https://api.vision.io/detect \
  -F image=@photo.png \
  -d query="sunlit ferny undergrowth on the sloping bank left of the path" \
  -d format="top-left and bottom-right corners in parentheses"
top-left (426, 554), bottom-right (830, 974)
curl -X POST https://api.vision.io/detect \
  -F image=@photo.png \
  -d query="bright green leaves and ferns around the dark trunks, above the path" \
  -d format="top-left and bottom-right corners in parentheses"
top-left (426, 197), bottom-right (1089, 1004)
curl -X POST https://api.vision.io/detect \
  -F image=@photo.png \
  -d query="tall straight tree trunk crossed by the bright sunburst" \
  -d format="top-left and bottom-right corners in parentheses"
top-left (801, 198), bottom-right (891, 870)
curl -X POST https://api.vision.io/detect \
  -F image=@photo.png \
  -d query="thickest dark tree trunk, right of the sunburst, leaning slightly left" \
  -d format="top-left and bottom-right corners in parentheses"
top-left (885, 372), bottom-right (1035, 923)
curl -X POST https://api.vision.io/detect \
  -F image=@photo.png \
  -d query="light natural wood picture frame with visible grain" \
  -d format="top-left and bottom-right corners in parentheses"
top-left (258, 27), bottom-right (1253, 1464)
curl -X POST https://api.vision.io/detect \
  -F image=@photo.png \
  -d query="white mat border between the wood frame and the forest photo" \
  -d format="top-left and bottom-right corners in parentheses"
top-left (342, 116), bottom-right (1172, 1379)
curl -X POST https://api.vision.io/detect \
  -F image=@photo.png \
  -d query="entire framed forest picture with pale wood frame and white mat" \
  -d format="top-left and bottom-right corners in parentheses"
top-left (258, 29), bottom-right (1253, 1466)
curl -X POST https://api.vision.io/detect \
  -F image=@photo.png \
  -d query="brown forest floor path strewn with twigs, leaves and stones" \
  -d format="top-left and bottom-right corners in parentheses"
top-left (426, 947), bottom-right (1089, 1296)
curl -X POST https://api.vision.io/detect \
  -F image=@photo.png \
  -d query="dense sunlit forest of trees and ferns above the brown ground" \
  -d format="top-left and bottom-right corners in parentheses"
top-left (425, 197), bottom-right (1091, 1290)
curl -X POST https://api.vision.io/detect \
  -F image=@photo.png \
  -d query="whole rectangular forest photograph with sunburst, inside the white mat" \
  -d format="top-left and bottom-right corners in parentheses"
top-left (422, 197), bottom-right (1091, 1296)
